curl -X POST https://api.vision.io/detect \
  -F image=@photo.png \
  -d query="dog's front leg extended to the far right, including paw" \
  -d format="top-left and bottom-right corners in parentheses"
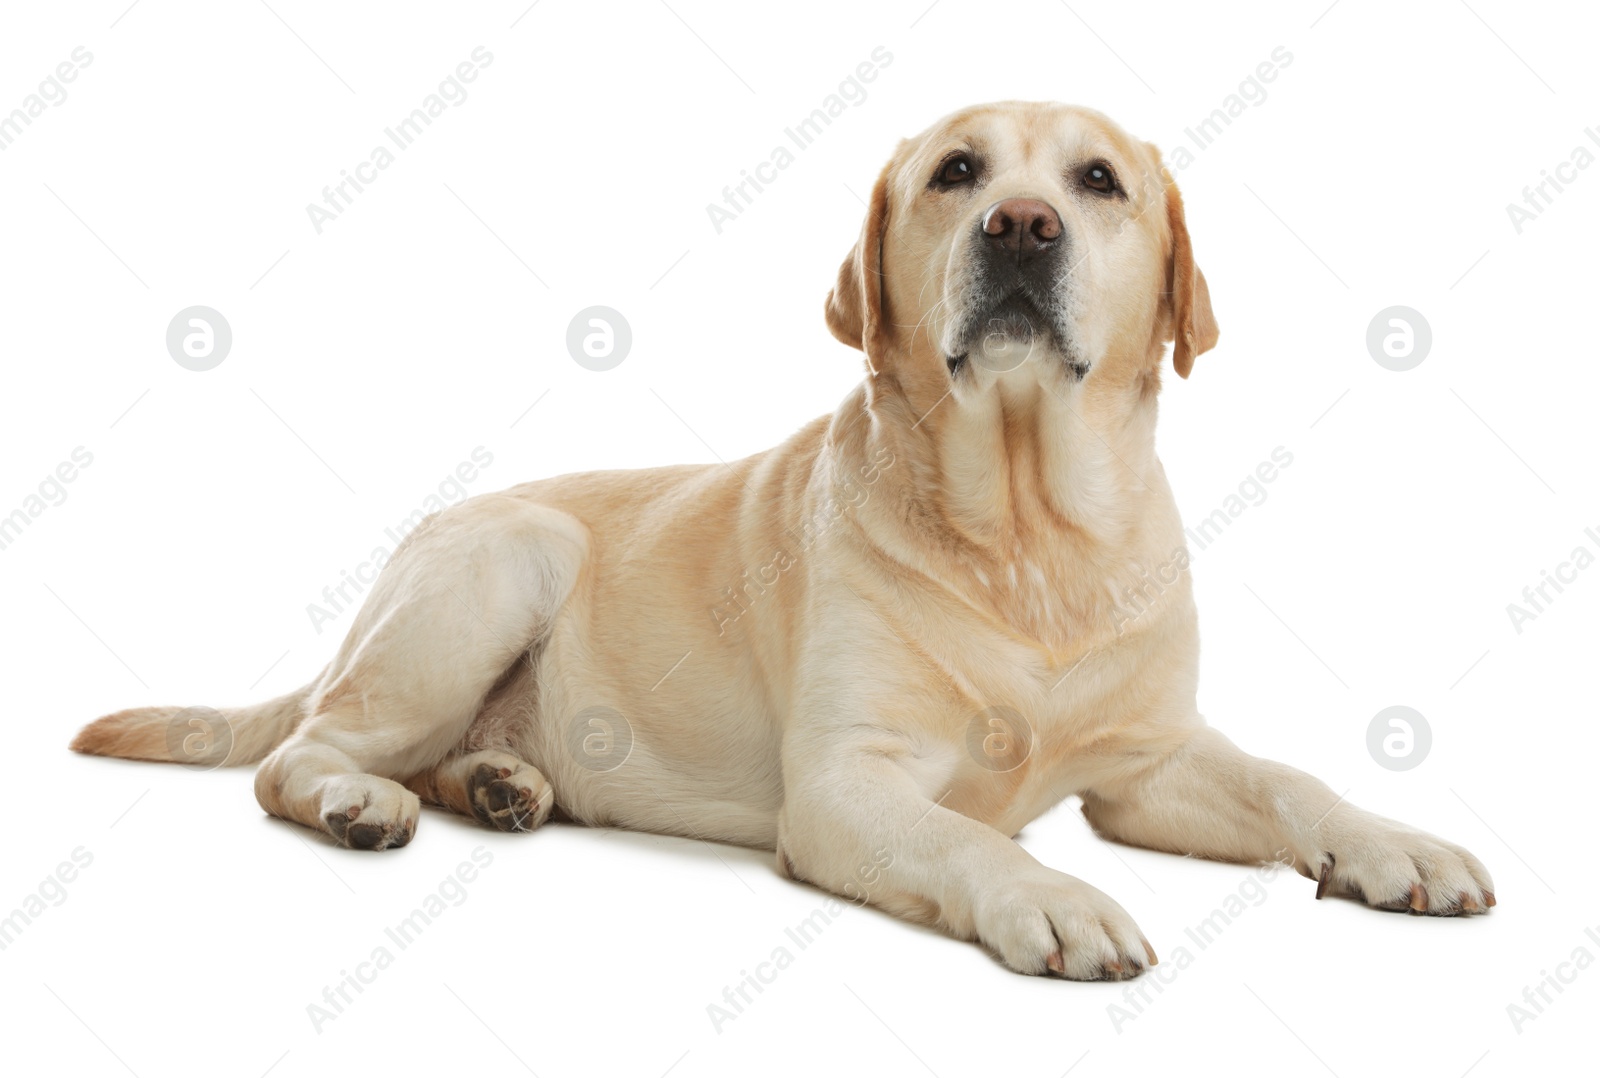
top-left (1083, 725), bottom-right (1494, 916)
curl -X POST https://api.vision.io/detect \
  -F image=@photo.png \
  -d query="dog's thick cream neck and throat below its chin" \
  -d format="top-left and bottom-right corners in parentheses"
top-left (832, 355), bottom-right (1171, 651)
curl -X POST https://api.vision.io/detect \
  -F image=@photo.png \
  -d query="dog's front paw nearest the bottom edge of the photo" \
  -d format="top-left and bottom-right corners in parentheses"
top-left (974, 868), bottom-right (1157, 980)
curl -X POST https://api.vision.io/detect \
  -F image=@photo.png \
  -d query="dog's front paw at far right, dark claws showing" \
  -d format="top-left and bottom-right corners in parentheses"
top-left (1302, 814), bottom-right (1494, 916)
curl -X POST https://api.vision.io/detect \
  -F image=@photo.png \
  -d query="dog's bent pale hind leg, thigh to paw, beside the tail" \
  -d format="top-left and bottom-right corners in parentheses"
top-left (256, 494), bottom-right (587, 849)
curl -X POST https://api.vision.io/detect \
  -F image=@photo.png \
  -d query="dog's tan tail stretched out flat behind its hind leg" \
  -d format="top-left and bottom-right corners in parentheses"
top-left (69, 681), bottom-right (317, 768)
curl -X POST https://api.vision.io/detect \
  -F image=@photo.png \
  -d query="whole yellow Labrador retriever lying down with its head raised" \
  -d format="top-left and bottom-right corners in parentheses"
top-left (72, 102), bottom-right (1494, 979)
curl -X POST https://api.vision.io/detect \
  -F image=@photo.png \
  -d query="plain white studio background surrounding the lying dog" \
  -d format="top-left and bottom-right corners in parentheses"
top-left (0, 0), bottom-right (1600, 1078)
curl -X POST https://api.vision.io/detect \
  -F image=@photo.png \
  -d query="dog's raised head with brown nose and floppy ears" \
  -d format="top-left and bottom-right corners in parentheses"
top-left (827, 102), bottom-right (1218, 384)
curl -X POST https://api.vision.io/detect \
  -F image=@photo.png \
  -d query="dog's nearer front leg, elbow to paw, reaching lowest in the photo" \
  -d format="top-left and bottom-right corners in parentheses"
top-left (778, 726), bottom-right (1155, 980)
